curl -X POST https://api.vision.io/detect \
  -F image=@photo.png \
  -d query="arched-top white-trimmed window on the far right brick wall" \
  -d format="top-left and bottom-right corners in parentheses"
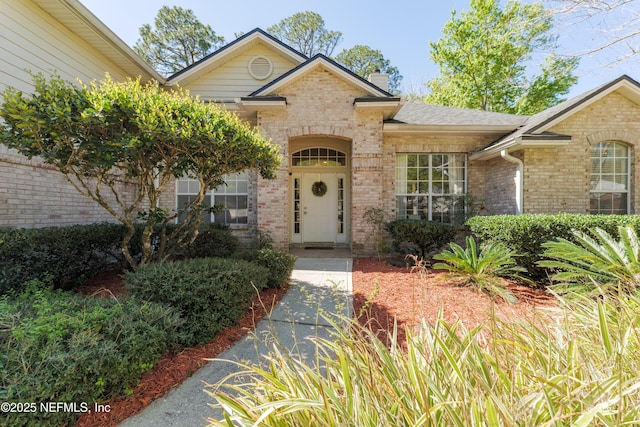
top-left (589, 141), bottom-right (630, 214)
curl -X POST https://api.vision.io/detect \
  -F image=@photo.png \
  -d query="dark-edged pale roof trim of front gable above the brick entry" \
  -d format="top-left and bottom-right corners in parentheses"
top-left (249, 54), bottom-right (395, 99)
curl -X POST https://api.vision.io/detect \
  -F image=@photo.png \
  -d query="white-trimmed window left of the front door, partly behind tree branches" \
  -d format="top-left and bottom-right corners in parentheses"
top-left (176, 171), bottom-right (249, 225)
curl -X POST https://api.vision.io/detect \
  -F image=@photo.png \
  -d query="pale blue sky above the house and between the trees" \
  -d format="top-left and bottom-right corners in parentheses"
top-left (80, 0), bottom-right (640, 97)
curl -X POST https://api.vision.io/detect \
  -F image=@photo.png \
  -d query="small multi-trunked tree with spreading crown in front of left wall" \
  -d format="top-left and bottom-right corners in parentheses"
top-left (0, 75), bottom-right (280, 266)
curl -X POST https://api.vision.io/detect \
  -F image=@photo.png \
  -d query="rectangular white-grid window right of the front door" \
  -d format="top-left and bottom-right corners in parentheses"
top-left (396, 153), bottom-right (466, 223)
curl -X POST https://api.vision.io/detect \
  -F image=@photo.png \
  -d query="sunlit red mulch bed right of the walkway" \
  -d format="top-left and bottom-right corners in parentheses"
top-left (353, 258), bottom-right (555, 344)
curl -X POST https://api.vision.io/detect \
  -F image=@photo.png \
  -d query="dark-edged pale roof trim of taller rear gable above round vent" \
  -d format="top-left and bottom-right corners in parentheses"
top-left (167, 28), bottom-right (307, 86)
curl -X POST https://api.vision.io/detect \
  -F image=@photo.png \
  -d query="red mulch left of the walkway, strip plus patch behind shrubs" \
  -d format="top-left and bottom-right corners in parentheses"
top-left (72, 272), bottom-right (287, 427)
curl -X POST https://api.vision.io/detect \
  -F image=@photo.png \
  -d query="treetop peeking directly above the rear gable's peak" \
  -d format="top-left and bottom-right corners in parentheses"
top-left (267, 11), bottom-right (342, 57)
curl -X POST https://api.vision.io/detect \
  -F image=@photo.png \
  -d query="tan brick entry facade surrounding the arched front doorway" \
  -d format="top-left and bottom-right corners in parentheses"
top-left (257, 67), bottom-right (382, 251)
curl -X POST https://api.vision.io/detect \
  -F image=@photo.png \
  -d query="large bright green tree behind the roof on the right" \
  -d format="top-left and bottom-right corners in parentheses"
top-left (425, 0), bottom-right (578, 114)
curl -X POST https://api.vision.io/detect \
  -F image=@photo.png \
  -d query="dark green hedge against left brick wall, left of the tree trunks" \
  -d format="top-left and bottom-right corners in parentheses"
top-left (0, 223), bottom-right (125, 294)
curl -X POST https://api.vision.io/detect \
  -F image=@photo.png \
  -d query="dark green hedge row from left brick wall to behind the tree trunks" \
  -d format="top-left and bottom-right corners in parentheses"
top-left (0, 223), bottom-right (240, 295)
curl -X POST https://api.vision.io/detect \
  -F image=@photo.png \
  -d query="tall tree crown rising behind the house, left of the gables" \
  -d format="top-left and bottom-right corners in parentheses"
top-left (133, 6), bottom-right (224, 75)
